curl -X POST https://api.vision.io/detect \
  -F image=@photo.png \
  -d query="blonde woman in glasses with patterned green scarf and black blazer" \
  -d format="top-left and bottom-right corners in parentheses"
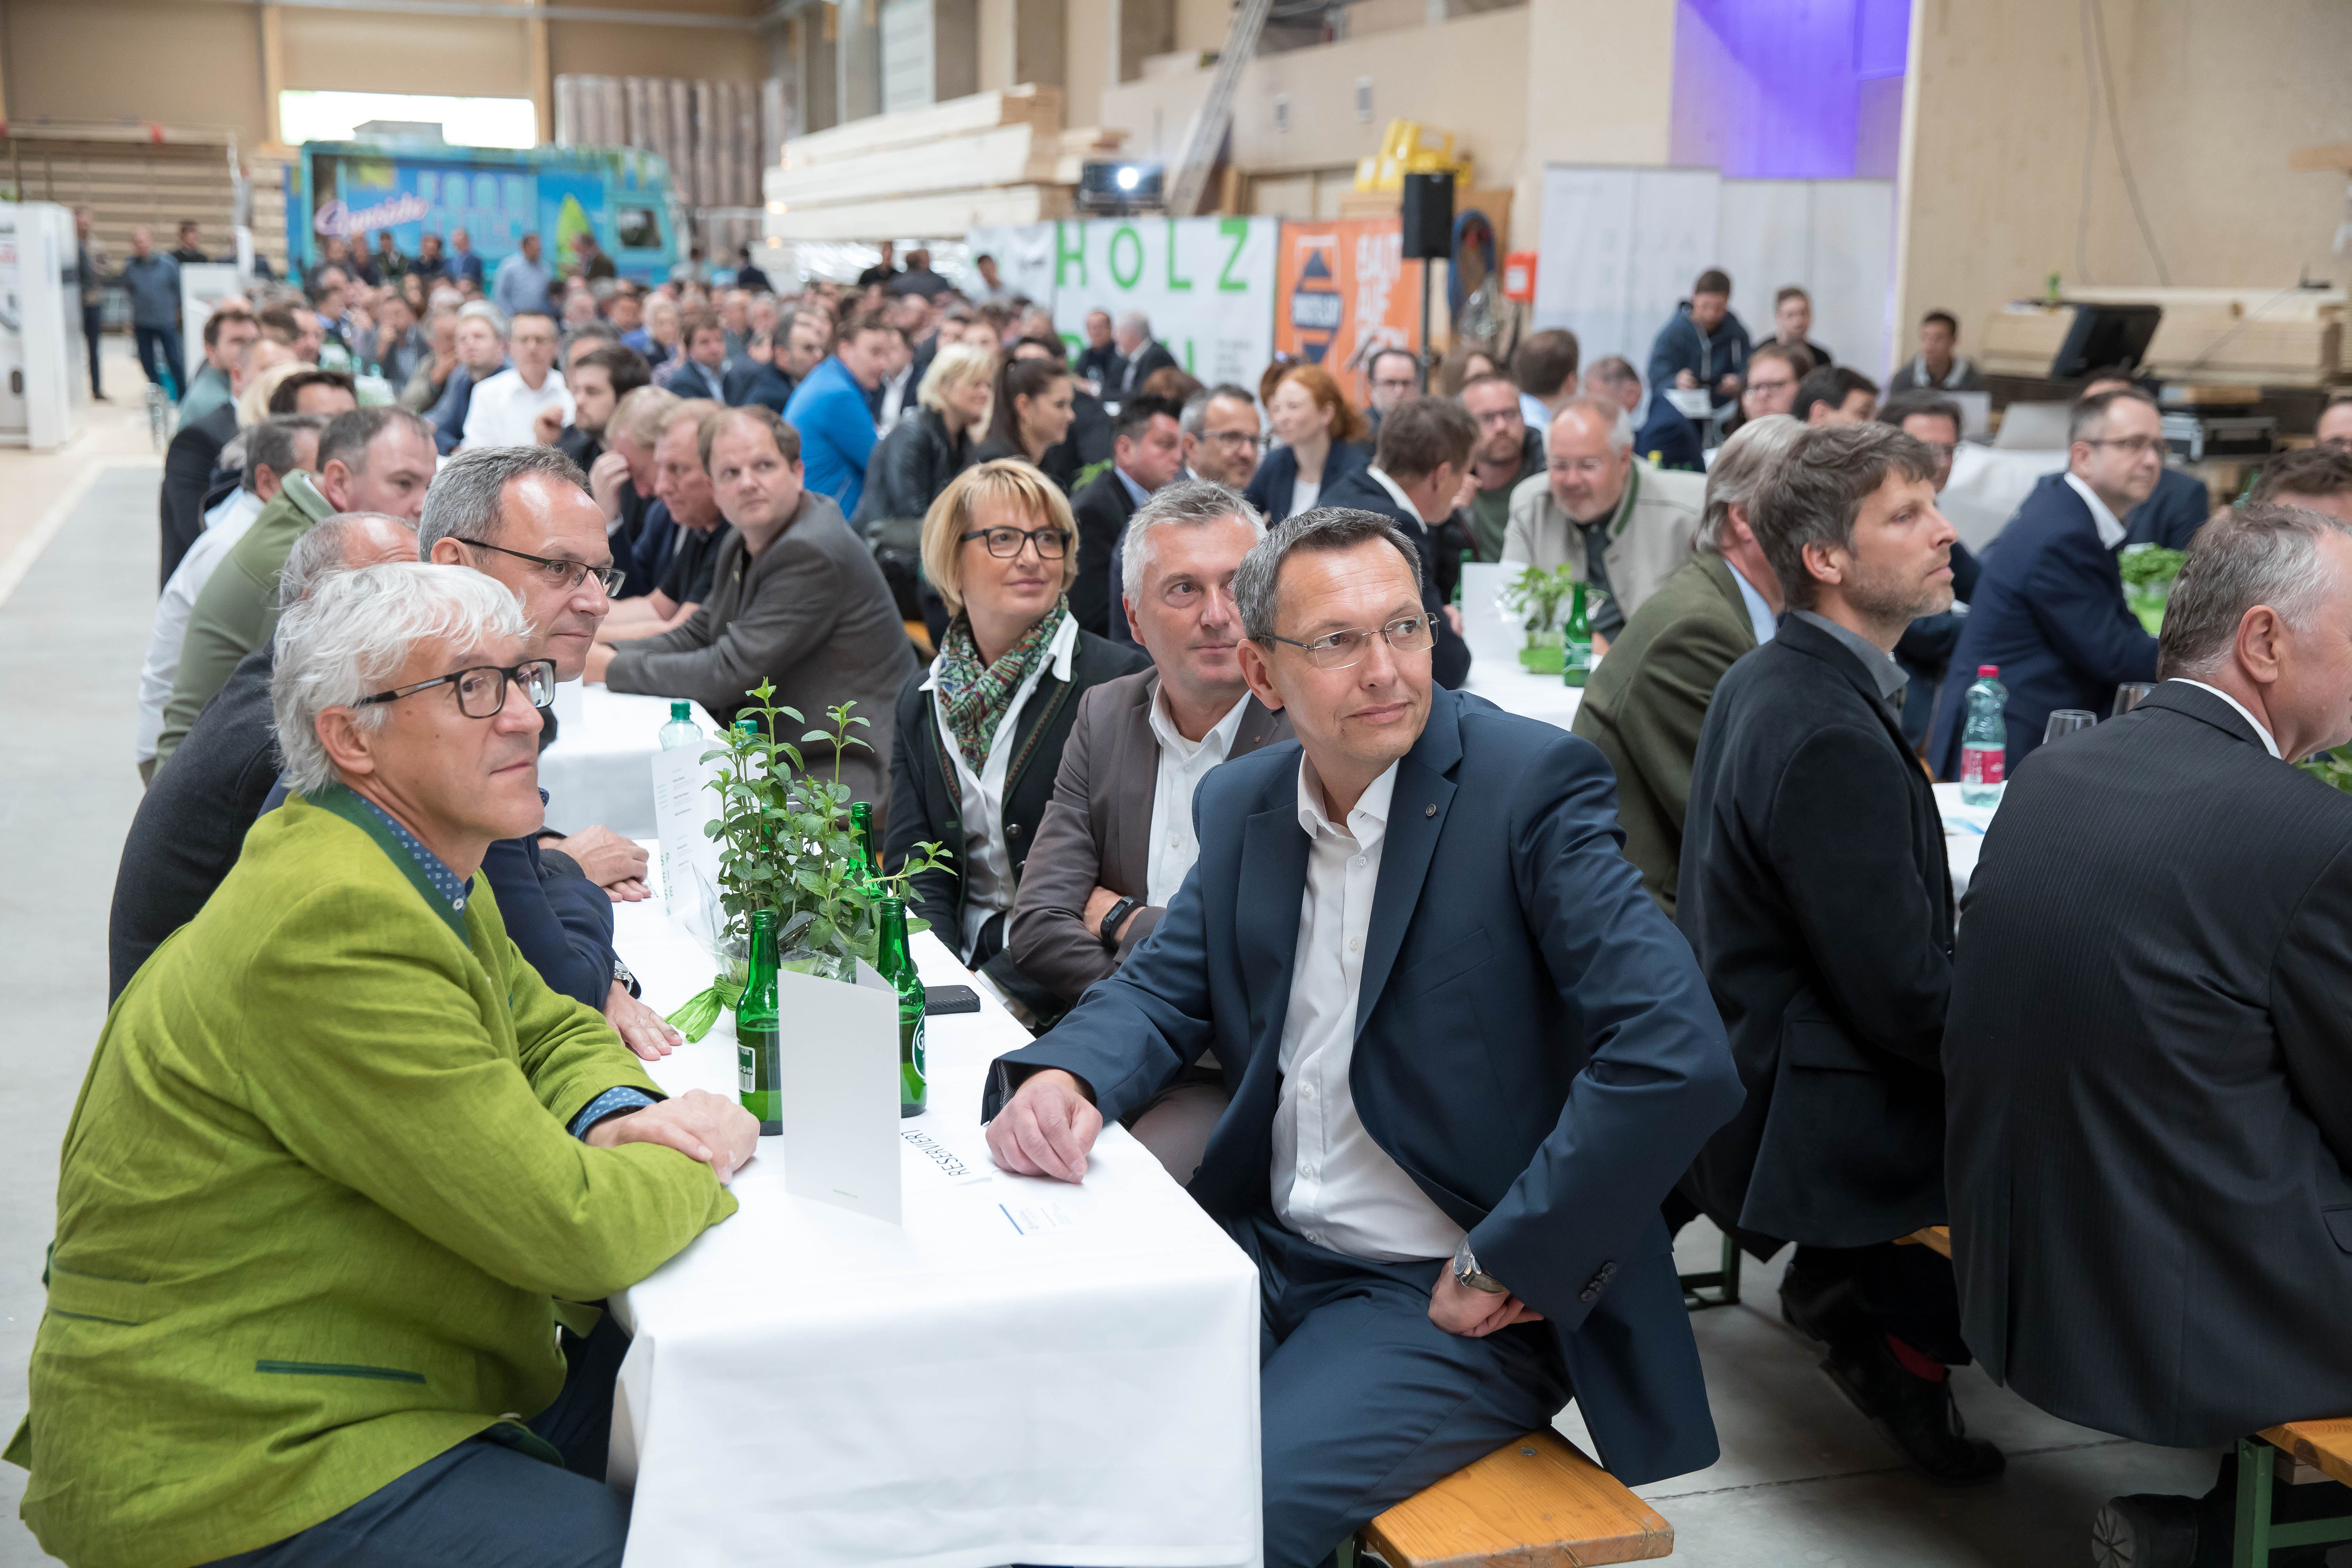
top-left (882, 461), bottom-right (1148, 1020)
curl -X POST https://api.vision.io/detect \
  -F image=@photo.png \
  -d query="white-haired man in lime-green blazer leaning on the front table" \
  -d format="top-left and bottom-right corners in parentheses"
top-left (7, 562), bottom-right (757, 1568)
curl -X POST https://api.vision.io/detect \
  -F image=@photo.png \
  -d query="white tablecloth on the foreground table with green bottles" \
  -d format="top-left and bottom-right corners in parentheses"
top-left (614, 903), bottom-right (1261, 1568)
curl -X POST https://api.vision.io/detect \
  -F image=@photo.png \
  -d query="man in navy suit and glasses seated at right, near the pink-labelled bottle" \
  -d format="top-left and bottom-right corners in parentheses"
top-left (1926, 388), bottom-right (2164, 778)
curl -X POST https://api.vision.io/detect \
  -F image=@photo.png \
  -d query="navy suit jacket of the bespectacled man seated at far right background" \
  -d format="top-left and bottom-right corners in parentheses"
top-left (1926, 473), bottom-right (2157, 778)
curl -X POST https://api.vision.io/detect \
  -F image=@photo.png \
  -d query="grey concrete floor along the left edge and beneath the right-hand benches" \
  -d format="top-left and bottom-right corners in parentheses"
top-left (0, 362), bottom-right (2216, 1568)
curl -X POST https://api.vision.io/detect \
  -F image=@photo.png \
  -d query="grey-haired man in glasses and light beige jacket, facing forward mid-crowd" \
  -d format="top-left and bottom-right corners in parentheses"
top-left (1503, 397), bottom-right (1708, 654)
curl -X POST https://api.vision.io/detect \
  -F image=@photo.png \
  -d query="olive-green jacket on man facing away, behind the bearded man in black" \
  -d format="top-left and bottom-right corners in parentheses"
top-left (1569, 550), bottom-right (1757, 919)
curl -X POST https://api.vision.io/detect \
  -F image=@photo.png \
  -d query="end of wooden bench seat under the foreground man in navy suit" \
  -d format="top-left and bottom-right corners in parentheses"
top-left (1355, 1432), bottom-right (1675, 1568)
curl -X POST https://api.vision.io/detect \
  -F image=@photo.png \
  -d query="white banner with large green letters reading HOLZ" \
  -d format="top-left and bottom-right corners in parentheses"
top-left (966, 216), bottom-right (1279, 388)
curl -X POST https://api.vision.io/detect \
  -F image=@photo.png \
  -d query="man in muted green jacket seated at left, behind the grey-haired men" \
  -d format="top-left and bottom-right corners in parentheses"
top-left (155, 409), bottom-right (433, 769)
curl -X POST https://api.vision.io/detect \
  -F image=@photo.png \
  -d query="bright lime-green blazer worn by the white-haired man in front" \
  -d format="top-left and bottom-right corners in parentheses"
top-left (7, 787), bottom-right (736, 1568)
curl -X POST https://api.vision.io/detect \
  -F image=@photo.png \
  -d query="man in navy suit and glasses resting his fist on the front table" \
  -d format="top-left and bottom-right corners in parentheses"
top-left (983, 508), bottom-right (1740, 1568)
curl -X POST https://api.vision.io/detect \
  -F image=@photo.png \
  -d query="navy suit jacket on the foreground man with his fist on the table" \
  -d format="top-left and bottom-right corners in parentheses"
top-left (983, 689), bottom-right (1740, 1483)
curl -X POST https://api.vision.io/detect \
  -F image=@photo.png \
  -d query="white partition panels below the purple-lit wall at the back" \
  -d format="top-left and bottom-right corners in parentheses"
top-left (1536, 165), bottom-right (1894, 378)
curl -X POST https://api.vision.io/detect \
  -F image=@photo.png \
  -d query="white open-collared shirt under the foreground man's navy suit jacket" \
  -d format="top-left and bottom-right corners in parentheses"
top-left (1272, 757), bottom-right (1463, 1262)
